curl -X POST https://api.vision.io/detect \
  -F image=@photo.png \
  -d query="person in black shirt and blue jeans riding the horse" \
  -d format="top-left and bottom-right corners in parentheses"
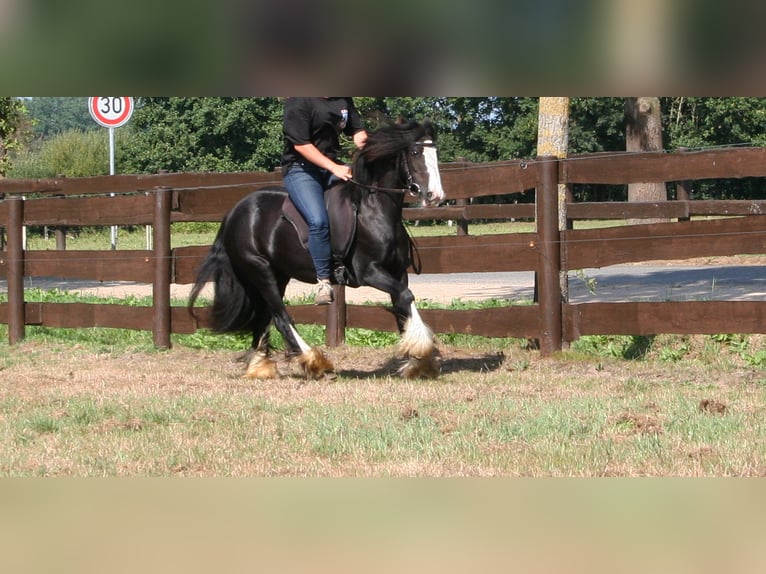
top-left (282, 98), bottom-right (367, 305)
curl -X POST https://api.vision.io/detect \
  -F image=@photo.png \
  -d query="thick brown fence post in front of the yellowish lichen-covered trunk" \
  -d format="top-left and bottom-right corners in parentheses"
top-left (535, 156), bottom-right (563, 356)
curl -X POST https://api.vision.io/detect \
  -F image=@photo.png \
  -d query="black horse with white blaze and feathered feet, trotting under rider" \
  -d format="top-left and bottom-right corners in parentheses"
top-left (189, 121), bottom-right (444, 378)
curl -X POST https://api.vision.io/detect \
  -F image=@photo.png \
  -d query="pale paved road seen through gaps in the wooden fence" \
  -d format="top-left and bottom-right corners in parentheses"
top-left (0, 265), bottom-right (766, 303)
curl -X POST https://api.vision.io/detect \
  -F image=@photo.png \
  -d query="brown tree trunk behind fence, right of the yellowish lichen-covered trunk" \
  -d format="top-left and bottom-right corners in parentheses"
top-left (625, 98), bottom-right (668, 224)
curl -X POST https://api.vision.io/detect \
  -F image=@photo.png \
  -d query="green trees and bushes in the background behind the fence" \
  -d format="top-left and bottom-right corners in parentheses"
top-left (9, 97), bottom-right (766, 201)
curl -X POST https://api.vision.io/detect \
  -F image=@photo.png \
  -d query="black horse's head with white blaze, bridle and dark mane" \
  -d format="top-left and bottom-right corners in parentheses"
top-left (353, 120), bottom-right (444, 206)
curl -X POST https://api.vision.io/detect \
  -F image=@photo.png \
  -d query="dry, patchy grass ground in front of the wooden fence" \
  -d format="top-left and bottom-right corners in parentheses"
top-left (0, 342), bottom-right (766, 476)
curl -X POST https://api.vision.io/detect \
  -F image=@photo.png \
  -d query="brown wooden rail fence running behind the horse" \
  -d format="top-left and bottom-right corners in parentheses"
top-left (0, 148), bottom-right (766, 354)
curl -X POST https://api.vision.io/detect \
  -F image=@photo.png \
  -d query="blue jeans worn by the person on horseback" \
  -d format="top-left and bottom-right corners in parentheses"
top-left (284, 162), bottom-right (332, 279)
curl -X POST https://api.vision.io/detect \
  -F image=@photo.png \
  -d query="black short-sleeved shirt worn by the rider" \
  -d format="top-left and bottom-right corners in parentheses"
top-left (282, 98), bottom-right (364, 171)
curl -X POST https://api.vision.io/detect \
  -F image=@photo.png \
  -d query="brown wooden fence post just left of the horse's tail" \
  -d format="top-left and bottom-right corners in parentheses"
top-left (152, 187), bottom-right (172, 349)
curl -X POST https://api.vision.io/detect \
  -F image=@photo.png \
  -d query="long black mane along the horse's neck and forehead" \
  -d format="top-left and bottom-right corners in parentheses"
top-left (352, 120), bottom-right (435, 183)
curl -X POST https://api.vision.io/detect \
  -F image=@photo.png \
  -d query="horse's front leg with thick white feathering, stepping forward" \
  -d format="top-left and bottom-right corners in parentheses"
top-left (367, 273), bottom-right (440, 378)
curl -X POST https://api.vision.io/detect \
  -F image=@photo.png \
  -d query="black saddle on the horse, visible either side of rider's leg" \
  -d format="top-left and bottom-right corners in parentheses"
top-left (282, 185), bottom-right (358, 285)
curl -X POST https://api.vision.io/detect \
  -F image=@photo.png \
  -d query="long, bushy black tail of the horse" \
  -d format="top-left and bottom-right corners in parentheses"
top-left (187, 221), bottom-right (254, 333)
